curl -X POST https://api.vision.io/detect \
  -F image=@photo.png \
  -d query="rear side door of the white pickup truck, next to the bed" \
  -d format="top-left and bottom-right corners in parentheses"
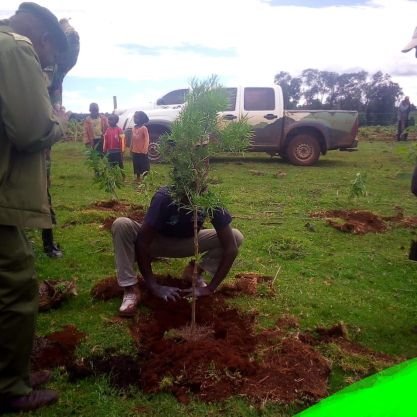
top-left (241, 87), bottom-right (283, 150)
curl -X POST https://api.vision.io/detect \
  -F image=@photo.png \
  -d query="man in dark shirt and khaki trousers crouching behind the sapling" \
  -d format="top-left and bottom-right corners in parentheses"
top-left (112, 187), bottom-right (243, 317)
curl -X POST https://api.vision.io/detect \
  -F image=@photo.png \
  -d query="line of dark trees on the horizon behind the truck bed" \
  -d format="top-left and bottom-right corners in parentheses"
top-left (274, 68), bottom-right (415, 125)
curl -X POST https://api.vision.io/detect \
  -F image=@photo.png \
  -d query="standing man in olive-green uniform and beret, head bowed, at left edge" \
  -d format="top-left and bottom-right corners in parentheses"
top-left (0, 2), bottom-right (68, 412)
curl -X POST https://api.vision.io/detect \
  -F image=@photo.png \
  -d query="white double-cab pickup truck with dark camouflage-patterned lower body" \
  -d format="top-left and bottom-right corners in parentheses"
top-left (121, 85), bottom-right (358, 166)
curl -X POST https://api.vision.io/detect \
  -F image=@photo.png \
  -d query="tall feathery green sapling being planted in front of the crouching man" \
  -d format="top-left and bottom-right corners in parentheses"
top-left (161, 76), bottom-right (252, 331)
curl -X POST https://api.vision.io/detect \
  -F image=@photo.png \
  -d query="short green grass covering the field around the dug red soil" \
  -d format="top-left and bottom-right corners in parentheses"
top-left (25, 136), bottom-right (417, 417)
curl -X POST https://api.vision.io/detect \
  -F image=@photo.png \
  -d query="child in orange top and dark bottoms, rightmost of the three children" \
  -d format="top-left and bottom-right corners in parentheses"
top-left (130, 111), bottom-right (151, 182)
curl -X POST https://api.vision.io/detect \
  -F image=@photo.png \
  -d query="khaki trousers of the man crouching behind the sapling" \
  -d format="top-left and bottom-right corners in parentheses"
top-left (112, 217), bottom-right (243, 287)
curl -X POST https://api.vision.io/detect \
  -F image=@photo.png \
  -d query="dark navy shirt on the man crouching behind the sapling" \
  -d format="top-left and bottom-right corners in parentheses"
top-left (144, 187), bottom-right (232, 238)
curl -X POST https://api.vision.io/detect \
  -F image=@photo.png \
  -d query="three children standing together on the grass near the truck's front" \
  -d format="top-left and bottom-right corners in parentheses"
top-left (84, 103), bottom-right (150, 182)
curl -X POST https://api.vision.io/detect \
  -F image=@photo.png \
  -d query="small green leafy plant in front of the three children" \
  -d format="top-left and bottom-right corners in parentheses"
top-left (86, 148), bottom-right (124, 201)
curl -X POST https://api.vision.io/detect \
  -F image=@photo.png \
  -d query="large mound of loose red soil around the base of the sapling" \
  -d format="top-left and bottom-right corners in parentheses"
top-left (125, 277), bottom-right (330, 403)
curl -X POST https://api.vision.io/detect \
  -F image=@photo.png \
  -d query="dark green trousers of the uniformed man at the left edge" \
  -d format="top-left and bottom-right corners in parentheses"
top-left (0, 225), bottom-right (38, 398)
